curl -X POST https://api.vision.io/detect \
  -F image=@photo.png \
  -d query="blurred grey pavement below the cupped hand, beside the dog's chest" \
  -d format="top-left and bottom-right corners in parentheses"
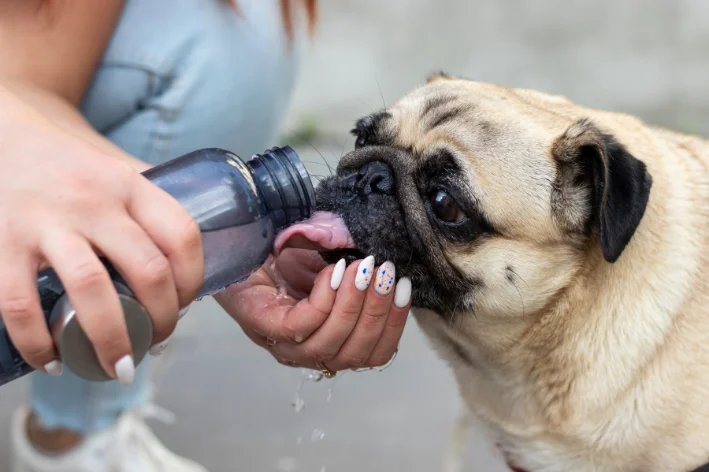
top-left (0, 300), bottom-right (505, 472)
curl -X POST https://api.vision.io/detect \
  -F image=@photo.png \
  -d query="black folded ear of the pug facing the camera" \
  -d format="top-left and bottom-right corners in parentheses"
top-left (552, 119), bottom-right (652, 262)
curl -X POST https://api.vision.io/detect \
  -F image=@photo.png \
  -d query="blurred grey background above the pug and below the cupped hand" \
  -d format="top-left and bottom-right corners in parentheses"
top-left (0, 0), bottom-right (709, 472)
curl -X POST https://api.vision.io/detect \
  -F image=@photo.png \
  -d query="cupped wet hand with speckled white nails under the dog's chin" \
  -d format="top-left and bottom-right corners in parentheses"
top-left (216, 249), bottom-right (411, 372)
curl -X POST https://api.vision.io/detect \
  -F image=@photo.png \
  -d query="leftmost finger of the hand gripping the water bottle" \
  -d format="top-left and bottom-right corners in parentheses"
top-left (0, 248), bottom-right (61, 375)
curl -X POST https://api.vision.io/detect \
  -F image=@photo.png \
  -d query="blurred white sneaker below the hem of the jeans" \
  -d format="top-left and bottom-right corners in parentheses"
top-left (10, 406), bottom-right (207, 472)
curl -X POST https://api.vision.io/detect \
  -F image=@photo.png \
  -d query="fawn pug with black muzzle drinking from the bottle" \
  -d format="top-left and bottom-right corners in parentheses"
top-left (278, 74), bottom-right (709, 472)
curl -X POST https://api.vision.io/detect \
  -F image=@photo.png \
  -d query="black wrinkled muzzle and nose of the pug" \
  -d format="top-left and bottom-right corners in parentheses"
top-left (317, 146), bottom-right (474, 315)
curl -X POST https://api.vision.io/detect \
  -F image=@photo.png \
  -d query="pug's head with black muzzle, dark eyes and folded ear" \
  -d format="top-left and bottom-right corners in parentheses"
top-left (318, 75), bottom-right (651, 338)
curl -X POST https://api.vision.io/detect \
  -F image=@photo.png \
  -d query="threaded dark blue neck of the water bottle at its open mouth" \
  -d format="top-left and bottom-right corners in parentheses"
top-left (247, 146), bottom-right (315, 231)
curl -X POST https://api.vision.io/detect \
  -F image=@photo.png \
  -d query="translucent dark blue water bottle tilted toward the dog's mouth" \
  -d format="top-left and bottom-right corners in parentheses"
top-left (0, 146), bottom-right (315, 385)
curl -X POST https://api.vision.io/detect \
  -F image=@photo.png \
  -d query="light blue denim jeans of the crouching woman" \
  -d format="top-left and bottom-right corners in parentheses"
top-left (31, 0), bottom-right (304, 433)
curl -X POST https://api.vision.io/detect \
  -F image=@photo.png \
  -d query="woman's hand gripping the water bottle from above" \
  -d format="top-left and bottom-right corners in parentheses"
top-left (0, 86), bottom-right (203, 382)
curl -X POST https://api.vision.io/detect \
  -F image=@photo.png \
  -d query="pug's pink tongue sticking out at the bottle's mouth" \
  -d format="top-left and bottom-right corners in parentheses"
top-left (273, 211), bottom-right (355, 255)
